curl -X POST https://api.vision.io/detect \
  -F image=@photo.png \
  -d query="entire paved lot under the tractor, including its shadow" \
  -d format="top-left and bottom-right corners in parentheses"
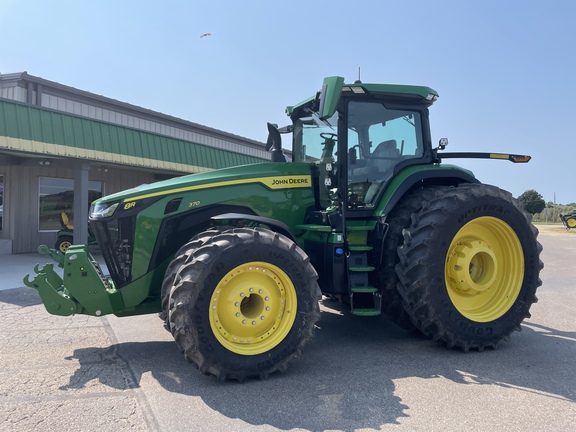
top-left (0, 227), bottom-right (576, 431)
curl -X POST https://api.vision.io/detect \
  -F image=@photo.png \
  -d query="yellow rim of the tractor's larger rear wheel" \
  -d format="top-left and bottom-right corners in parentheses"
top-left (445, 216), bottom-right (524, 322)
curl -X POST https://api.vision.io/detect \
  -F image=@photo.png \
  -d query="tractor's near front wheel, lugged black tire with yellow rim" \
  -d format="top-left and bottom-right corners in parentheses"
top-left (168, 228), bottom-right (321, 381)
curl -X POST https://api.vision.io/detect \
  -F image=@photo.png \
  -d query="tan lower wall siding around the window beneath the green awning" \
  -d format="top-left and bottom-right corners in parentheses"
top-left (0, 164), bottom-right (156, 253)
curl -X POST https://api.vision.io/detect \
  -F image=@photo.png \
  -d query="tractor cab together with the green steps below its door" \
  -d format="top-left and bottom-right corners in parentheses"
top-left (268, 77), bottom-right (446, 315)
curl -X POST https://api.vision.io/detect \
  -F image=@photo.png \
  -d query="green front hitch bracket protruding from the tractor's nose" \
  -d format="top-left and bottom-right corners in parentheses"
top-left (24, 245), bottom-right (124, 316)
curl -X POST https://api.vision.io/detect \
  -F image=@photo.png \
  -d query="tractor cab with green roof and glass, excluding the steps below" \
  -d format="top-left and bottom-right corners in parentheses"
top-left (268, 77), bottom-right (438, 215)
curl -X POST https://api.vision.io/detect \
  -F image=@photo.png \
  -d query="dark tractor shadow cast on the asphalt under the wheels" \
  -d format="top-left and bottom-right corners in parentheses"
top-left (61, 296), bottom-right (576, 431)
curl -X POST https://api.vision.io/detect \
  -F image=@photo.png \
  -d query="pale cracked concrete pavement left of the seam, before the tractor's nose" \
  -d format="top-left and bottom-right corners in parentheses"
top-left (0, 254), bottom-right (158, 431)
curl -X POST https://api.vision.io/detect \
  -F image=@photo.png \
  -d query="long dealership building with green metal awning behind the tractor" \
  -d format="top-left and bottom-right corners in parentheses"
top-left (0, 72), bottom-right (270, 253)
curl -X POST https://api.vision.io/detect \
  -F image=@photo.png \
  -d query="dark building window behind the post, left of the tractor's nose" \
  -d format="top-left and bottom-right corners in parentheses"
top-left (38, 177), bottom-right (102, 231)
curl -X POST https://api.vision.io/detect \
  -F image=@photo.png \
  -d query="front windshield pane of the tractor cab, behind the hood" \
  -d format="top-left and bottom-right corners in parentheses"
top-left (292, 114), bottom-right (338, 163)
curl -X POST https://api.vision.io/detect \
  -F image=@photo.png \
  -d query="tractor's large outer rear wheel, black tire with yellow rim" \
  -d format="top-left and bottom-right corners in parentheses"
top-left (396, 184), bottom-right (543, 351)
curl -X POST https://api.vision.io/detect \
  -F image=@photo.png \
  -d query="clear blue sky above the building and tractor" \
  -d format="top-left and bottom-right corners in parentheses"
top-left (0, 0), bottom-right (576, 204)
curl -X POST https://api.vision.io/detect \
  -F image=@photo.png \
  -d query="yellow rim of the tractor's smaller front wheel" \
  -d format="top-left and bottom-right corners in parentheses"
top-left (209, 261), bottom-right (297, 355)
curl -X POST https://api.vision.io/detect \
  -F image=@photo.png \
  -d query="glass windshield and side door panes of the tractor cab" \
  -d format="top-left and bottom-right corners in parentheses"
top-left (292, 100), bottom-right (424, 209)
